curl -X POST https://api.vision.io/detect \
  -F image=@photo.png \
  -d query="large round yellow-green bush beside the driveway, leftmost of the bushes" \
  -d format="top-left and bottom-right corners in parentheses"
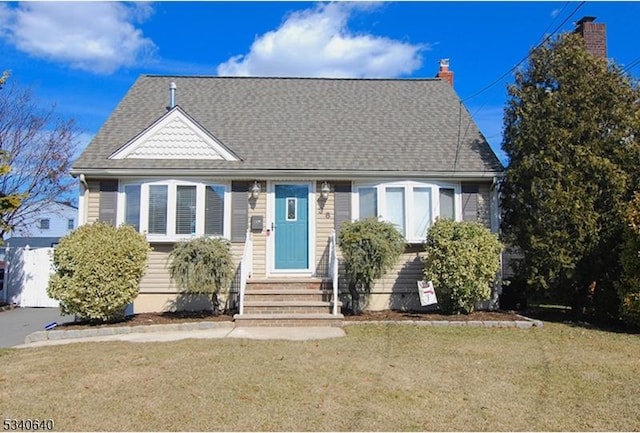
top-left (47, 222), bottom-right (150, 321)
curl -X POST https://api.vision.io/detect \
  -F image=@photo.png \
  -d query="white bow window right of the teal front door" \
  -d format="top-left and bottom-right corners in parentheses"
top-left (353, 181), bottom-right (460, 243)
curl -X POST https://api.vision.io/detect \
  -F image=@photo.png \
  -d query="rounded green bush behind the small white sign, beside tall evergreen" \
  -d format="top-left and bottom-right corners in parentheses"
top-left (424, 219), bottom-right (503, 314)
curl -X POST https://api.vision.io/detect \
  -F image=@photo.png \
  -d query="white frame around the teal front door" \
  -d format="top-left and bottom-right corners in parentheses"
top-left (266, 180), bottom-right (316, 276)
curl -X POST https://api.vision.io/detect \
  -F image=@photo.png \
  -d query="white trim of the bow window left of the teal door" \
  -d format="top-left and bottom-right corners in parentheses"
top-left (117, 179), bottom-right (231, 243)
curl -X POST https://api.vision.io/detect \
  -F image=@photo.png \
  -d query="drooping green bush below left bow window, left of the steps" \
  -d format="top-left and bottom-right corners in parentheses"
top-left (169, 237), bottom-right (234, 314)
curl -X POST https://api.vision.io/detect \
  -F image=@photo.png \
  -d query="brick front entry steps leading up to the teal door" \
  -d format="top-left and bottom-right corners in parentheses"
top-left (233, 278), bottom-right (344, 327)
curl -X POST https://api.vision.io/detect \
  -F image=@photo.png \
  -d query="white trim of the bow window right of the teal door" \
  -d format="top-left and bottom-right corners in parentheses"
top-left (351, 179), bottom-right (462, 243)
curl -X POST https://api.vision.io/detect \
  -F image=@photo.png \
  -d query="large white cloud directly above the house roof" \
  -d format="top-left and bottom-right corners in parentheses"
top-left (217, 3), bottom-right (428, 77)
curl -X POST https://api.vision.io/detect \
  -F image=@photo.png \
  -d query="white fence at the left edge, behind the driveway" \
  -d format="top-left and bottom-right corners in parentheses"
top-left (4, 247), bottom-right (59, 307)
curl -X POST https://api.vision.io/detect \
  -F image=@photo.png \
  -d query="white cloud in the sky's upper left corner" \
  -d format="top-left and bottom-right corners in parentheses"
top-left (0, 2), bottom-right (155, 74)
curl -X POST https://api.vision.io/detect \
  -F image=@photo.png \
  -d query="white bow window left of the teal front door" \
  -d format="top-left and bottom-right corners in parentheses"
top-left (118, 180), bottom-right (231, 241)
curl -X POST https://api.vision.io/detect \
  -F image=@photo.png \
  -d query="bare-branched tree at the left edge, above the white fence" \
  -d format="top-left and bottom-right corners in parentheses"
top-left (0, 77), bottom-right (78, 239)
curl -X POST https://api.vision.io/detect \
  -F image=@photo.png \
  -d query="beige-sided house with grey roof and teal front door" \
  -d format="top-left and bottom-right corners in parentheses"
top-left (72, 62), bottom-right (503, 324)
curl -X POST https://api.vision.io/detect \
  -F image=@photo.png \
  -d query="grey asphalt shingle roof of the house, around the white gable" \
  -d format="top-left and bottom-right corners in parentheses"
top-left (74, 75), bottom-right (503, 174)
